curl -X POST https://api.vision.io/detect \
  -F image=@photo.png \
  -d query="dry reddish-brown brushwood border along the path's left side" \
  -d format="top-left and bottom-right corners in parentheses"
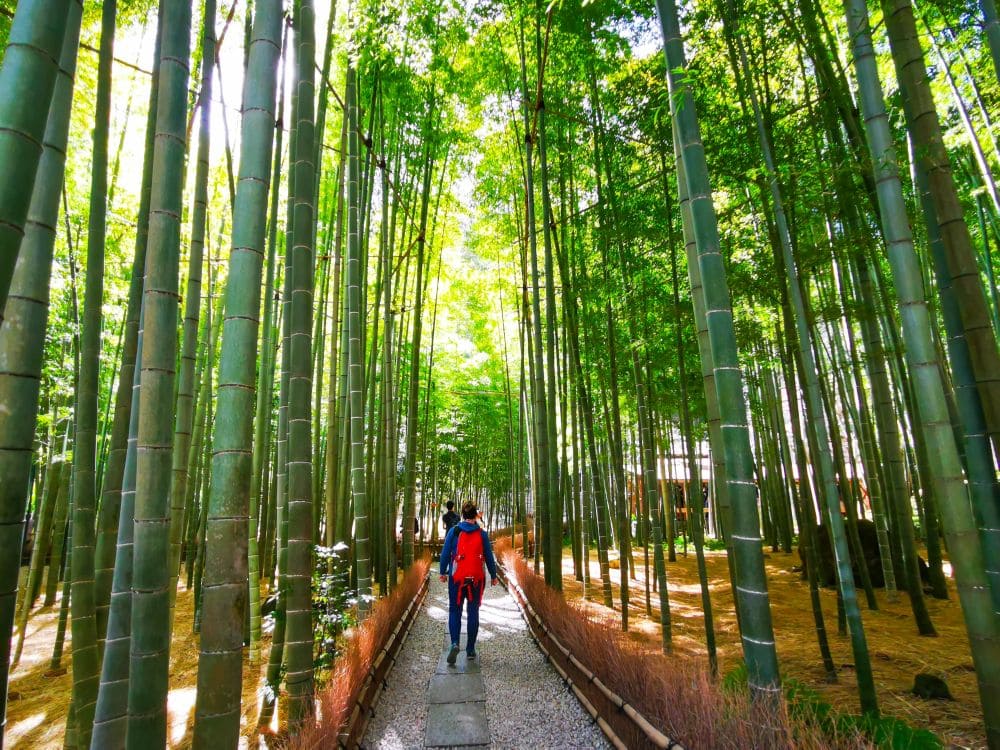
top-left (288, 558), bottom-right (430, 750)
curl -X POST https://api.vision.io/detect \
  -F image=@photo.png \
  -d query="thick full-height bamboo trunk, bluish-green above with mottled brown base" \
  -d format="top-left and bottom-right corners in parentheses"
top-left (194, 0), bottom-right (282, 748)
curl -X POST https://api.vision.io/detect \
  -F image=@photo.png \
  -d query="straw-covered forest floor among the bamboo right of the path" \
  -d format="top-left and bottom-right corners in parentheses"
top-left (563, 548), bottom-right (986, 748)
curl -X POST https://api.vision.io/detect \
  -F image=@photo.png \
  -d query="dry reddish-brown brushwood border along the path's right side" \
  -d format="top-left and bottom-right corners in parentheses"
top-left (498, 545), bottom-right (865, 748)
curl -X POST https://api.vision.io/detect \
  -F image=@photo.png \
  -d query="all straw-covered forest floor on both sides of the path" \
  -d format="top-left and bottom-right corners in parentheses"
top-left (5, 548), bottom-right (986, 749)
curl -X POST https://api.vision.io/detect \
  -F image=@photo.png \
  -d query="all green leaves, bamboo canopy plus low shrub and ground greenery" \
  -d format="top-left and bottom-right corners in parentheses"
top-left (0, 0), bottom-right (1000, 747)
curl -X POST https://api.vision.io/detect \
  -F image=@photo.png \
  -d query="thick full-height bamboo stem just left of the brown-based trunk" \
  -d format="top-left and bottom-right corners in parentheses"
top-left (126, 2), bottom-right (191, 748)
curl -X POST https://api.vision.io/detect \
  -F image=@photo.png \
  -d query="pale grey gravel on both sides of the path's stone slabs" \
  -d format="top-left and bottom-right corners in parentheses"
top-left (363, 571), bottom-right (610, 750)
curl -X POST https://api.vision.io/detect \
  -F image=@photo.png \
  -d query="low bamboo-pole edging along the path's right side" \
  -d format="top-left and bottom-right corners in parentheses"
top-left (499, 565), bottom-right (684, 750)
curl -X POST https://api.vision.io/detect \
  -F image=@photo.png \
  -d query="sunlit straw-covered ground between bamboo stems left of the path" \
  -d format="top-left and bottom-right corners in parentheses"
top-left (4, 583), bottom-right (270, 750)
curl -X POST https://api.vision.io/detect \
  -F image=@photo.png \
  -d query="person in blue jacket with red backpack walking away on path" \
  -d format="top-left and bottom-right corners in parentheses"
top-left (440, 500), bottom-right (497, 664)
